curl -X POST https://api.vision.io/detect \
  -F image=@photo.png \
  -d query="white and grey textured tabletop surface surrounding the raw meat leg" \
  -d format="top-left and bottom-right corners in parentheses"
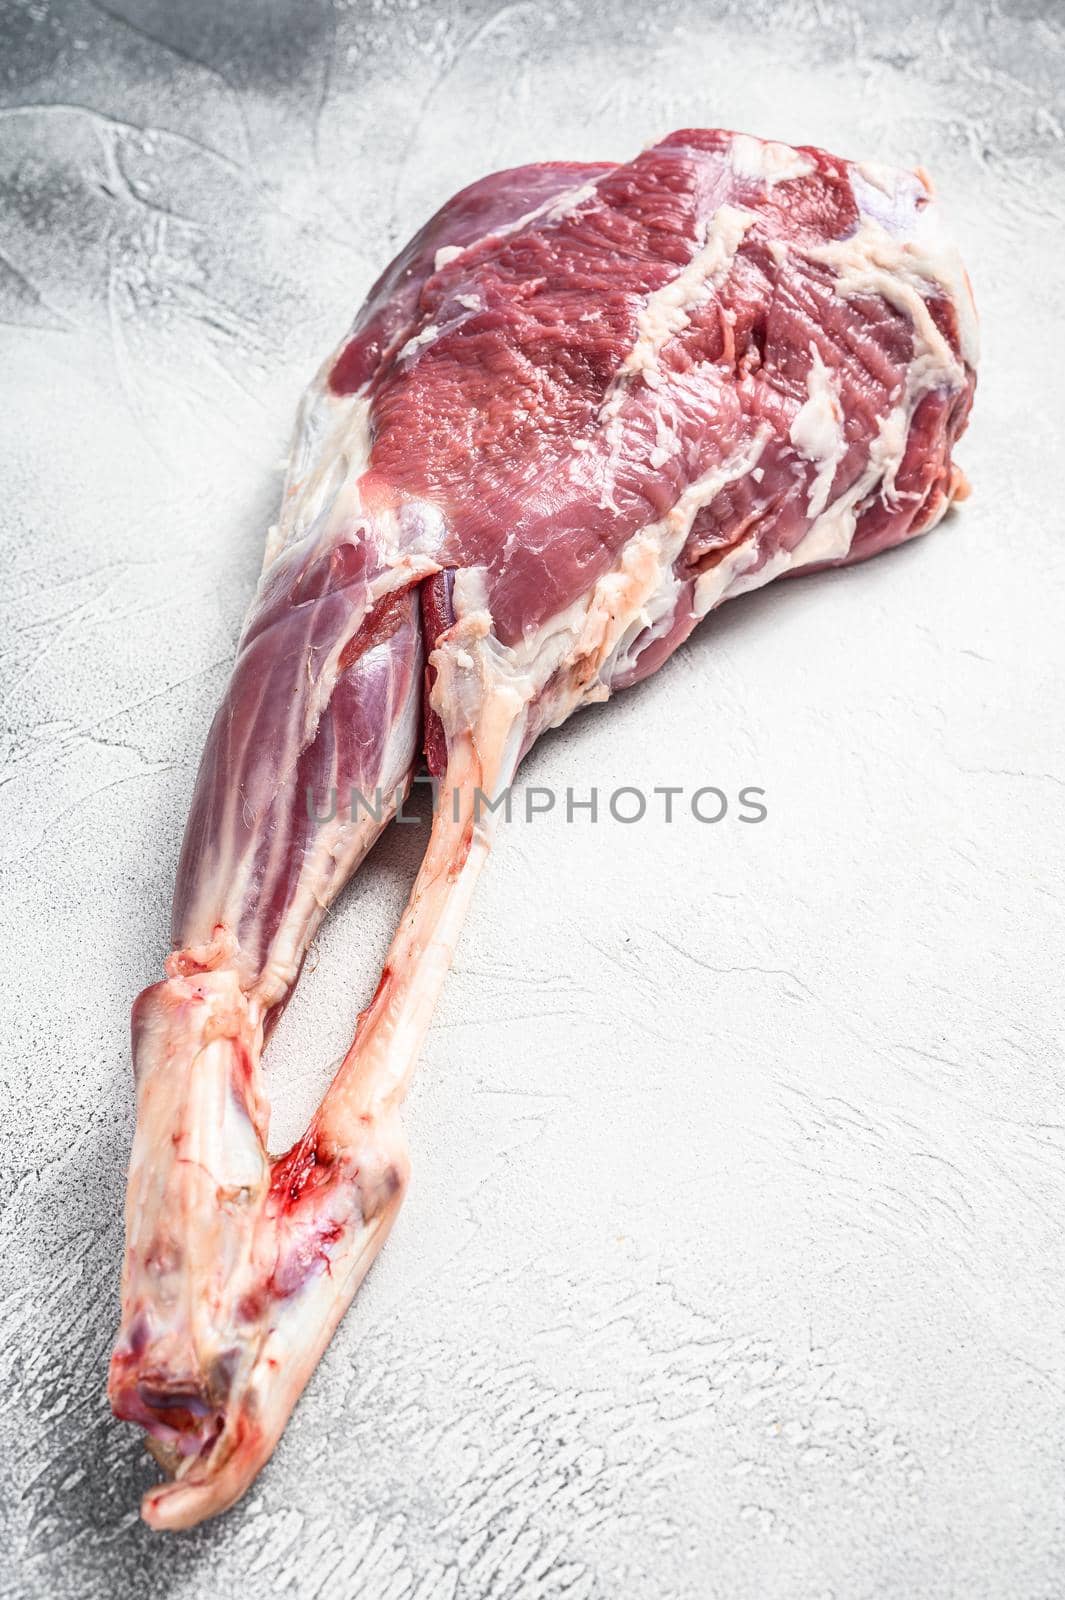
top-left (0, 0), bottom-right (1065, 1600)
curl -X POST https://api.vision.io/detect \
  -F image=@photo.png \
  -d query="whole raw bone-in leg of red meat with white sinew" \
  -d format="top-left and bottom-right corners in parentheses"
top-left (110, 130), bottom-right (975, 1528)
